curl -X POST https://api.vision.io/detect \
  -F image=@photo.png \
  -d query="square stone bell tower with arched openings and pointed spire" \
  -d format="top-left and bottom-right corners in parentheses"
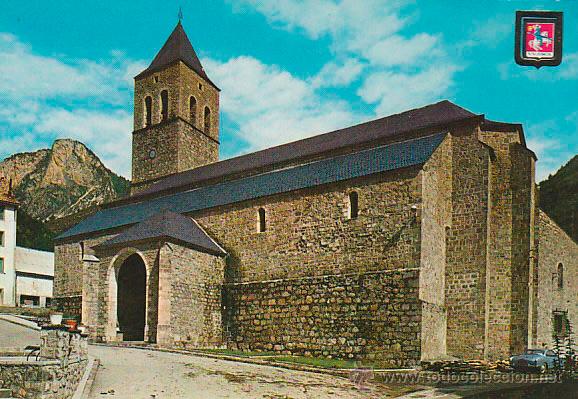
top-left (131, 21), bottom-right (220, 193)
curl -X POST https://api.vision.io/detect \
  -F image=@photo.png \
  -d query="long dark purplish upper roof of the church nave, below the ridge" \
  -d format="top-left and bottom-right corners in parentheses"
top-left (133, 100), bottom-right (477, 198)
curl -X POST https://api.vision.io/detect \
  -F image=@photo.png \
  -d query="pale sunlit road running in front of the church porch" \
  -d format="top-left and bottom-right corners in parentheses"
top-left (90, 346), bottom-right (385, 399)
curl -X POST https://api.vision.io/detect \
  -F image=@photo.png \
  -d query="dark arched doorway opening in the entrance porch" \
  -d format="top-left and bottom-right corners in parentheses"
top-left (117, 254), bottom-right (146, 341)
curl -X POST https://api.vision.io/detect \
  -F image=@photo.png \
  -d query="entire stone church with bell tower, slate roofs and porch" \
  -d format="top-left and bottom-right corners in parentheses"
top-left (55, 23), bottom-right (578, 366)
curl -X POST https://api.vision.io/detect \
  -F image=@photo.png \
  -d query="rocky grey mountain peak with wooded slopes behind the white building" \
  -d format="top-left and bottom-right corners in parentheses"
top-left (0, 140), bottom-right (130, 247)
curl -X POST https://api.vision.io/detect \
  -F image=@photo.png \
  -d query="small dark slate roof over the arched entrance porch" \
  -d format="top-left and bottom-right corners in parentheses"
top-left (97, 211), bottom-right (227, 255)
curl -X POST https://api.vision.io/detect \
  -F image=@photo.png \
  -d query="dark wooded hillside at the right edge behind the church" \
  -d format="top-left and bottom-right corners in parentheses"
top-left (540, 155), bottom-right (578, 242)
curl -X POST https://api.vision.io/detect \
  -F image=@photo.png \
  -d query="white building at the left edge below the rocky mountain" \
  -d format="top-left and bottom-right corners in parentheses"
top-left (0, 180), bottom-right (54, 306)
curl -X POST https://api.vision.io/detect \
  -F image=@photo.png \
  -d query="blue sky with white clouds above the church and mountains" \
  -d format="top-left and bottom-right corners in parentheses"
top-left (0, 0), bottom-right (578, 180)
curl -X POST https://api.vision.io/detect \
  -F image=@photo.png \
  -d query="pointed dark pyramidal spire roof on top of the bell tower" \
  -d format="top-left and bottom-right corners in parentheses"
top-left (135, 21), bottom-right (218, 89)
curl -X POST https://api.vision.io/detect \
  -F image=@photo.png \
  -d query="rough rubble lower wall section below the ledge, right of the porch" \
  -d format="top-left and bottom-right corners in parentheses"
top-left (224, 269), bottom-right (422, 367)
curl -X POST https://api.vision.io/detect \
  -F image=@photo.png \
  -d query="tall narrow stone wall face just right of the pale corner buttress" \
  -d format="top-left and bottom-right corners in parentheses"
top-left (445, 127), bottom-right (490, 359)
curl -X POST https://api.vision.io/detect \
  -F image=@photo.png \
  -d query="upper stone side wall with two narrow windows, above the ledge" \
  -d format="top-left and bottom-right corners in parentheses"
top-left (196, 168), bottom-right (421, 282)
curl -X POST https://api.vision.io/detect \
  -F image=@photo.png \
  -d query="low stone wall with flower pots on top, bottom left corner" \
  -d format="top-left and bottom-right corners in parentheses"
top-left (0, 327), bottom-right (88, 399)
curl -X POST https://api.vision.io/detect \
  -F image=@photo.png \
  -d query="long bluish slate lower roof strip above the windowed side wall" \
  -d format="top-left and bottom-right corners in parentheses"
top-left (57, 133), bottom-right (446, 240)
